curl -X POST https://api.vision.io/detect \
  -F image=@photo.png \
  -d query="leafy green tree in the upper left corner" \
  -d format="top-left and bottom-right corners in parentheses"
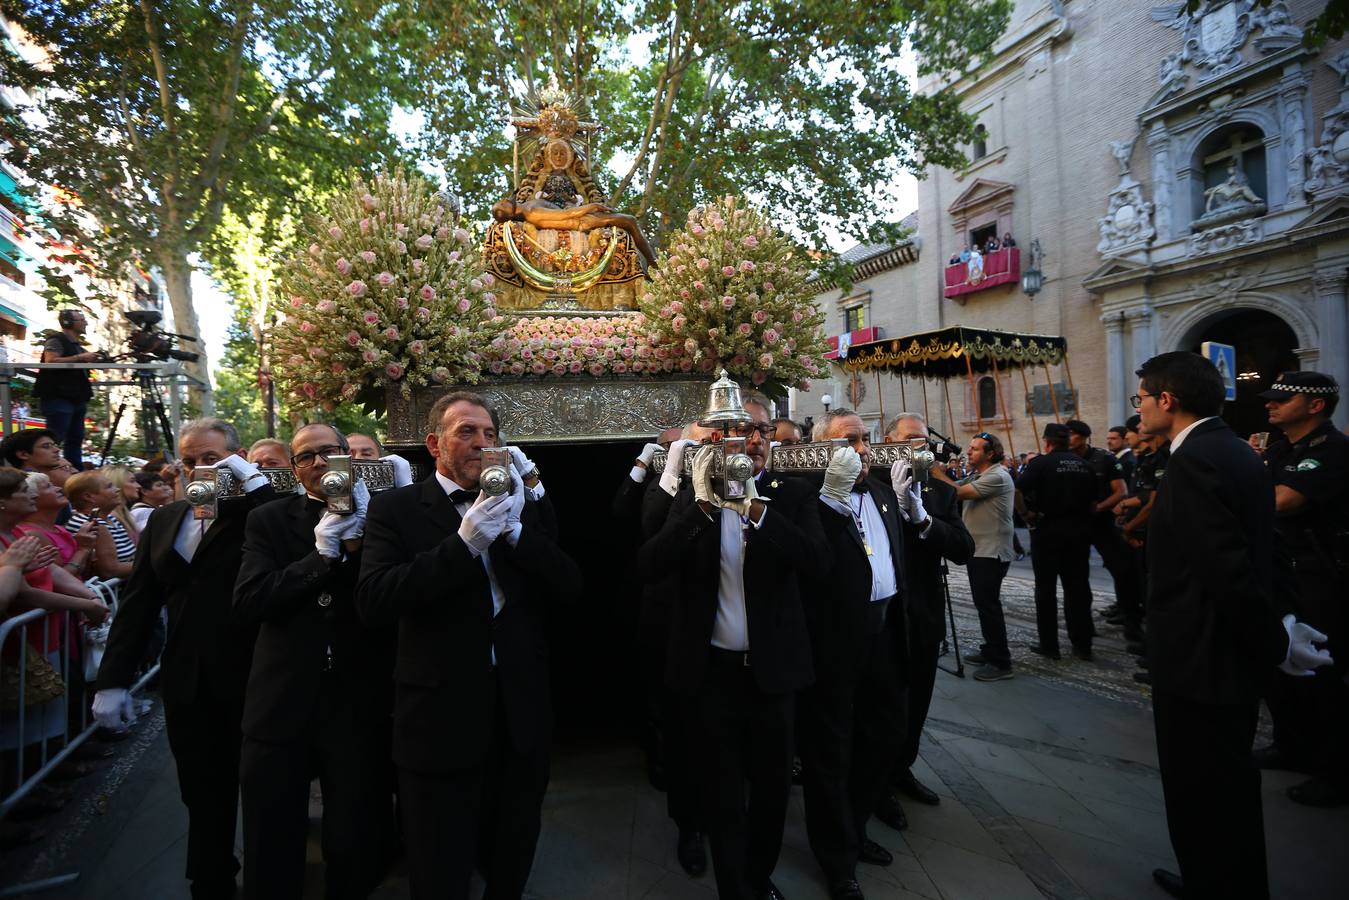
top-left (0, 0), bottom-right (402, 403)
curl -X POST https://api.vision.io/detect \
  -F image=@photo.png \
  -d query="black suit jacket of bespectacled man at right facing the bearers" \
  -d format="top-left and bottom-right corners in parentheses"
top-left (1148, 418), bottom-right (1288, 703)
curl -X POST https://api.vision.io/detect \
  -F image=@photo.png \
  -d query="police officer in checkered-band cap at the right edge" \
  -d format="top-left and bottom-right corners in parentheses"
top-left (1256, 372), bottom-right (1349, 807)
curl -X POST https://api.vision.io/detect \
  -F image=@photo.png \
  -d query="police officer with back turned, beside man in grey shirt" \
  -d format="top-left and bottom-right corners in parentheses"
top-left (1017, 422), bottom-right (1097, 660)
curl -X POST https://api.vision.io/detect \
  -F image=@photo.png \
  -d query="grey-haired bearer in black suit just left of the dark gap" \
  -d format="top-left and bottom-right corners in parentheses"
top-left (356, 391), bottom-right (580, 900)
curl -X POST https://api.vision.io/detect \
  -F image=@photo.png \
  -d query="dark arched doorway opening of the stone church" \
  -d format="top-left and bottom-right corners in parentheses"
top-left (1182, 309), bottom-right (1298, 437)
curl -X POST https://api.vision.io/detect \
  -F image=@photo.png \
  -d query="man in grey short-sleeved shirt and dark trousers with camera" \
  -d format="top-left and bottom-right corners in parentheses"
top-left (932, 432), bottom-right (1016, 681)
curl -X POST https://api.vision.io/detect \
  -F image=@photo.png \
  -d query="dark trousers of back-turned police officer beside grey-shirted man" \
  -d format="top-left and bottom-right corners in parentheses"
top-left (1031, 522), bottom-right (1095, 650)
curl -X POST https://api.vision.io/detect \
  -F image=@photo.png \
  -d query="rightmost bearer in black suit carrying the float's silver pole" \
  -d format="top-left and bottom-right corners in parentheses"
top-left (877, 413), bottom-right (974, 830)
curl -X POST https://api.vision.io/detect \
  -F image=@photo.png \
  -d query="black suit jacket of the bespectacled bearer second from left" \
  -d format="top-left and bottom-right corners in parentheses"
top-left (235, 494), bottom-right (394, 743)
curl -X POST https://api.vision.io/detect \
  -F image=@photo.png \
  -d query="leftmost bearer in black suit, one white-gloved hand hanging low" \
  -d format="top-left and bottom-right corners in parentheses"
top-left (93, 418), bottom-right (275, 900)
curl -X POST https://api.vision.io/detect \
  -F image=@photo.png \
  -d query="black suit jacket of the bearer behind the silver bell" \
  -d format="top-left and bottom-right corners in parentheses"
top-left (637, 472), bottom-right (831, 694)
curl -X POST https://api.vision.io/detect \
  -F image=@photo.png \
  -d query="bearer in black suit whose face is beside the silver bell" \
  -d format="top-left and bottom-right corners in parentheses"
top-left (637, 398), bottom-right (828, 900)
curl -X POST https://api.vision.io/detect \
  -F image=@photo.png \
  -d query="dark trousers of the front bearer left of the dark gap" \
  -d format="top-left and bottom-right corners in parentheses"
top-left (398, 674), bottom-right (548, 900)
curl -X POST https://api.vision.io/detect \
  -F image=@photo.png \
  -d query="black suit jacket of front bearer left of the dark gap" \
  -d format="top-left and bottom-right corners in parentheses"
top-left (356, 474), bottom-right (580, 773)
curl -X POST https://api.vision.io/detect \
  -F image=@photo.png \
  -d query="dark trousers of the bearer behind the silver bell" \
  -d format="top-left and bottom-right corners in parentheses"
top-left (687, 649), bottom-right (796, 900)
